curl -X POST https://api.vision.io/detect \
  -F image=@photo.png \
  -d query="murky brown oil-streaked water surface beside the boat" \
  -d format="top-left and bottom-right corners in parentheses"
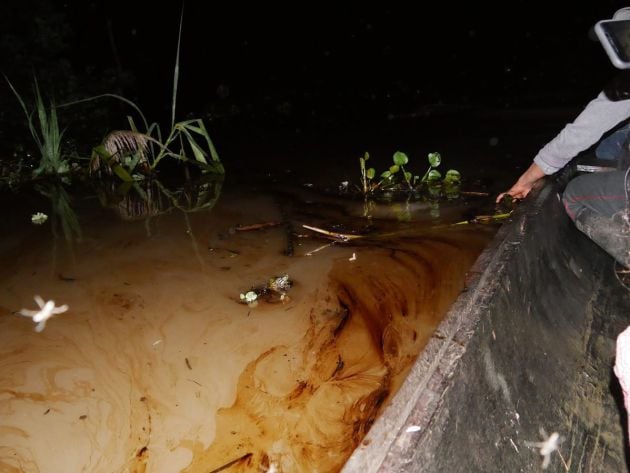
top-left (0, 178), bottom-right (494, 473)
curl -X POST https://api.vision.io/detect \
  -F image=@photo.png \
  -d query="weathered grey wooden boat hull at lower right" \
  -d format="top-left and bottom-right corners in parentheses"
top-left (342, 178), bottom-right (630, 473)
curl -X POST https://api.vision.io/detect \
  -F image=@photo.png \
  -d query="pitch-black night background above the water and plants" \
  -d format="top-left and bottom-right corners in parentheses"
top-left (0, 0), bottom-right (626, 180)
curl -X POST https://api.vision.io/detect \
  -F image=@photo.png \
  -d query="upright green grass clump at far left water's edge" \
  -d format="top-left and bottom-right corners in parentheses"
top-left (4, 76), bottom-right (70, 176)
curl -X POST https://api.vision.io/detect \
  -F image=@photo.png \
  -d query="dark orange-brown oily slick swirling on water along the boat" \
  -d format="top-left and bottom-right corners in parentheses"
top-left (186, 234), bottom-right (486, 472)
